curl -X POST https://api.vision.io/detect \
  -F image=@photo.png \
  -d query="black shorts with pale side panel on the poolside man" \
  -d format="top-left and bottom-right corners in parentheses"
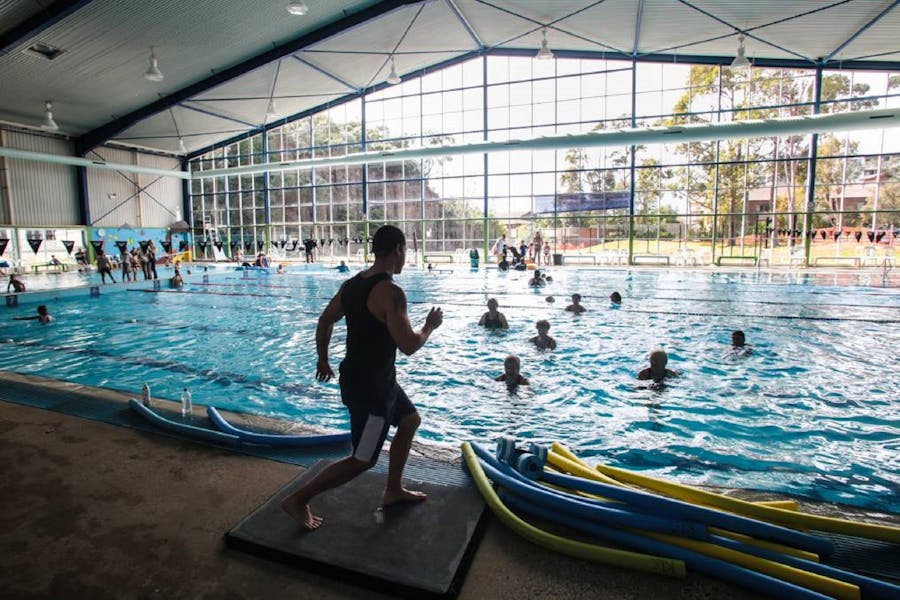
top-left (341, 383), bottom-right (416, 462)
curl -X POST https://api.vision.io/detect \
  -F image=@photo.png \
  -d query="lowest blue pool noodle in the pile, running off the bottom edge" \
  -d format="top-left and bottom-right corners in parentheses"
top-left (500, 492), bottom-right (831, 600)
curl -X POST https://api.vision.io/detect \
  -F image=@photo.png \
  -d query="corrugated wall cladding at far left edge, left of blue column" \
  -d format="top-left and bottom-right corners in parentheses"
top-left (3, 131), bottom-right (81, 227)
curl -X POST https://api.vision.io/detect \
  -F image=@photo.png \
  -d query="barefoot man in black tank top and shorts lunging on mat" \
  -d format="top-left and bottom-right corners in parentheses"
top-left (281, 225), bottom-right (444, 531)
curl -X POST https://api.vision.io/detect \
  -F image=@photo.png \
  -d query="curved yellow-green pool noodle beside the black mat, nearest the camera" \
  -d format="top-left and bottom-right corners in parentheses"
top-left (462, 443), bottom-right (685, 579)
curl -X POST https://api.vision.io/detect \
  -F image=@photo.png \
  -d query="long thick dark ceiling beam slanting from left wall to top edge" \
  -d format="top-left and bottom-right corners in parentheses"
top-left (75, 0), bottom-right (420, 156)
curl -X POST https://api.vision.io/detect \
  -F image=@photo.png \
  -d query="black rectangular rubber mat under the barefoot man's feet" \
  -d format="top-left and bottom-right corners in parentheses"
top-left (225, 461), bottom-right (485, 598)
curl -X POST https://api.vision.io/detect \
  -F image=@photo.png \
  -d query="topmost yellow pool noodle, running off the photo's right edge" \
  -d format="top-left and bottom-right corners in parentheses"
top-left (549, 442), bottom-right (900, 544)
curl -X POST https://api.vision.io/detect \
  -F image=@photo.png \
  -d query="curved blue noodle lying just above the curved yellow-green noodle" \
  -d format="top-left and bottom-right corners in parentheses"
top-left (471, 444), bottom-right (709, 540)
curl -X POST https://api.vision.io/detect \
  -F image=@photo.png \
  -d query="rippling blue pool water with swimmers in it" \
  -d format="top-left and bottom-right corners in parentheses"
top-left (0, 267), bottom-right (900, 513)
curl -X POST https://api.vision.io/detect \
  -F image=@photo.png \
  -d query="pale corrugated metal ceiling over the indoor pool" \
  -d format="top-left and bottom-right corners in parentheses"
top-left (0, 0), bottom-right (900, 153)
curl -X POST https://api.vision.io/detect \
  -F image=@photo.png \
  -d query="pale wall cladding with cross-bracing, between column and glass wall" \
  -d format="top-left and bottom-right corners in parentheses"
top-left (87, 147), bottom-right (182, 228)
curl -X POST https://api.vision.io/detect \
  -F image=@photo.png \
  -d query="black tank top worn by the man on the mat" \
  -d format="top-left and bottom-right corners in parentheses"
top-left (341, 273), bottom-right (397, 375)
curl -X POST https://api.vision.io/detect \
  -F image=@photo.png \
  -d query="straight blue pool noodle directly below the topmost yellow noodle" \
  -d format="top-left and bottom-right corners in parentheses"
top-left (541, 471), bottom-right (834, 555)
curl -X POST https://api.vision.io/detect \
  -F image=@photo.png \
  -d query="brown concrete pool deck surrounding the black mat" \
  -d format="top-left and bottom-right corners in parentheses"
top-left (0, 382), bottom-right (900, 600)
